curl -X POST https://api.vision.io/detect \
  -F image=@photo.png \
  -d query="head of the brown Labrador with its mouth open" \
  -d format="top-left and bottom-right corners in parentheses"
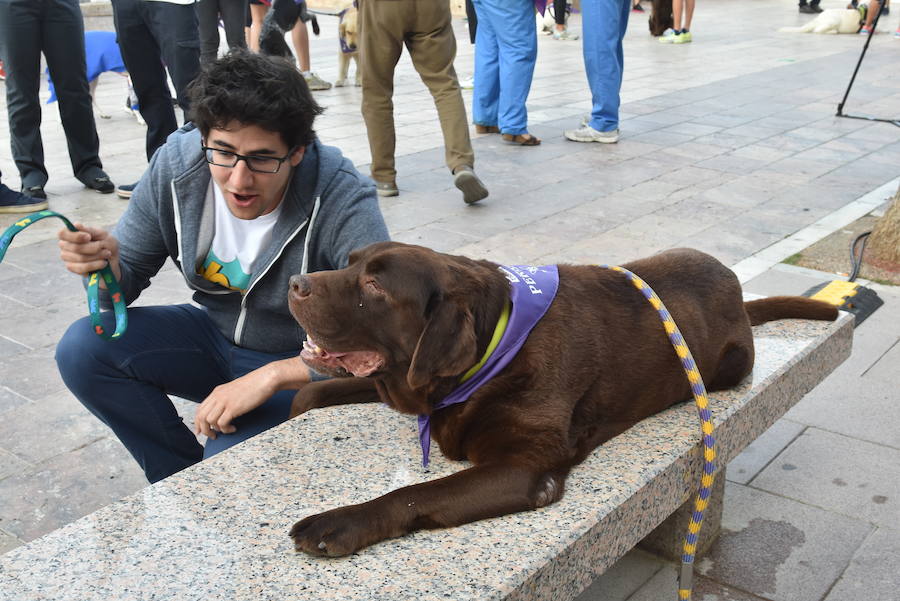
top-left (288, 242), bottom-right (508, 413)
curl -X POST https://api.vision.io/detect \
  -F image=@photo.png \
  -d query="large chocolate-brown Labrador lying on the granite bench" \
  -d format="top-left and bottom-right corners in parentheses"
top-left (289, 242), bottom-right (837, 556)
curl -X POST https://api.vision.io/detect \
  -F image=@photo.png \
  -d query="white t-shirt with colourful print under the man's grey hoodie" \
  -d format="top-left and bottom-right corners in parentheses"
top-left (200, 180), bottom-right (283, 293)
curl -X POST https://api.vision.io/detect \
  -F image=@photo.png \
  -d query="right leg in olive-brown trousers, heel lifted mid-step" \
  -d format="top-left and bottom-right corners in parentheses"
top-left (406, 2), bottom-right (488, 204)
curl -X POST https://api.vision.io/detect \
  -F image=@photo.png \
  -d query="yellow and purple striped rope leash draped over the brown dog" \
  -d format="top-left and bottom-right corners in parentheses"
top-left (601, 265), bottom-right (716, 601)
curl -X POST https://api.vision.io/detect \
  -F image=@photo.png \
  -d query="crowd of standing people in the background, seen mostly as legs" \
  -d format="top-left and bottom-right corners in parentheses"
top-left (0, 0), bottom-right (648, 212)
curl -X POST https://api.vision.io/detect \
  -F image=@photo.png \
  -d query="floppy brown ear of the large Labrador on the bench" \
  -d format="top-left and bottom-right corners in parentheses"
top-left (406, 300), bottom-right (477, 390)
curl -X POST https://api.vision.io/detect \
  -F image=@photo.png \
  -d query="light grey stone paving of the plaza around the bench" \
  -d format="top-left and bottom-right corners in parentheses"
top-left (0, 0), bottom-right (900, 601)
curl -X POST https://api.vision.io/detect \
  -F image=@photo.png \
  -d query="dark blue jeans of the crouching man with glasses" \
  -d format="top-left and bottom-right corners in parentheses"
top-left (56, 305), bottom-right (299, 482)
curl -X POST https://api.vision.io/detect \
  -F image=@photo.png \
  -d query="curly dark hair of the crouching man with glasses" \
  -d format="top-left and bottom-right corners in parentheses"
top-left (188, 49), bottom-right (323, 148)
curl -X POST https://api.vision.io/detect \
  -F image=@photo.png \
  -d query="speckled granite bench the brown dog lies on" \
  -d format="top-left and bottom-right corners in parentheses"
top-left (0, 314), bottom-right (853, 601)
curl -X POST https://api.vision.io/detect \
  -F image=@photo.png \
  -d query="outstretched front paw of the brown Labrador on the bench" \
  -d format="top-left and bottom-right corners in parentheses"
top-left (291, 505), bottom-right (385, 557)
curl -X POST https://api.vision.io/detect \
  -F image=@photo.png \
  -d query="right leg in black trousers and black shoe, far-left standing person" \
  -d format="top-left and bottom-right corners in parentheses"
top-left (41, 0), bottom-right (115, 188)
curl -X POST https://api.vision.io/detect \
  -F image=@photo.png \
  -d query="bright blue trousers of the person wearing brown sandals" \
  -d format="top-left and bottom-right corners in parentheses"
top-left (472, 0), bottom-right (537, 135)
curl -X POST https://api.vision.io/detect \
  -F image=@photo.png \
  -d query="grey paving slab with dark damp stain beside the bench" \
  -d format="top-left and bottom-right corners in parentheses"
top-left (696, 482), bottom-right (872, 601)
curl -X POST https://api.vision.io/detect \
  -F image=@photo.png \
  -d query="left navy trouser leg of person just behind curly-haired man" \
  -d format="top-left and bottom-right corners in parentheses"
top-left (112, 0), bottom-right (178, 161)
